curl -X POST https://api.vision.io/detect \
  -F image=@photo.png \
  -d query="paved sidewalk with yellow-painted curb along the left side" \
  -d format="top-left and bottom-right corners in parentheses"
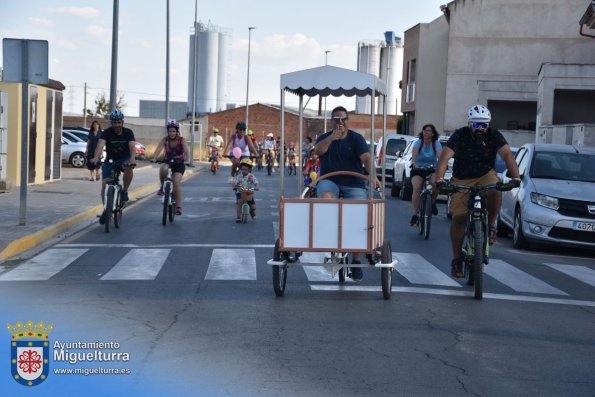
top-left (0, 162), bottom-right (207, 263)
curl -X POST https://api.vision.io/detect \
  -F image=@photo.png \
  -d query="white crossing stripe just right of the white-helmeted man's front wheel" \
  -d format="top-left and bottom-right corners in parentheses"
top-left (484, 259), bottom-right (568, 295)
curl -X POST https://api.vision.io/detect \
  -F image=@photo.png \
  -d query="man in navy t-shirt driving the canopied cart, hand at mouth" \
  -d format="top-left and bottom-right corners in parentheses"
top-left (314, 106), bottom-right (380, 281)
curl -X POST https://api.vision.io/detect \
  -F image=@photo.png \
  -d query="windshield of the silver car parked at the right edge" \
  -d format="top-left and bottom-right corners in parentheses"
top-left (531, 152), bottom-right (595, 182)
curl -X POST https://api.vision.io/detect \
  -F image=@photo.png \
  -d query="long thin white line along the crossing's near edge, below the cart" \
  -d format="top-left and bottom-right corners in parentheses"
top-left (310, 284), bottom-right (595, 307)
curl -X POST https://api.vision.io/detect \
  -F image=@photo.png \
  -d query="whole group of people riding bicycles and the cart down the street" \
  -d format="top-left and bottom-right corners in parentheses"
top-left (90, 104), bottom-right (520, 281)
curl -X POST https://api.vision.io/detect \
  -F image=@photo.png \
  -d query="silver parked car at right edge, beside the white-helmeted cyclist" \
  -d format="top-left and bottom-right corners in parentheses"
top-left (498, 144), bottom-right (595, 248)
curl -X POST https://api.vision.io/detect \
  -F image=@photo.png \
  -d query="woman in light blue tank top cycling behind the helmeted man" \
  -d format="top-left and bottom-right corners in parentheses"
top-left (410, 124), bottom-right (442, 226)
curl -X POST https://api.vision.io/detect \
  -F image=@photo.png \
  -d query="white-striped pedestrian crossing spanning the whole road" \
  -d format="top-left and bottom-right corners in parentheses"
top-left (0, 246), bottom-right (595, 306)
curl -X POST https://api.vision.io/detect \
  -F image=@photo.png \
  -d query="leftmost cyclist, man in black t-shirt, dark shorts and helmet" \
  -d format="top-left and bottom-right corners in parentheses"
top-left (89, 110), bottom-right (136, 224)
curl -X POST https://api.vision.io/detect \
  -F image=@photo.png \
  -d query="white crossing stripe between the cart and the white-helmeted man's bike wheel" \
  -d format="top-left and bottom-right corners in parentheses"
top-left (393, 252), bottom-right (461, 287)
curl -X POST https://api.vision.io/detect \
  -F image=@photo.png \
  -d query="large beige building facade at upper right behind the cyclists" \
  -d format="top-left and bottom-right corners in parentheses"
top-left (402, 0), bottom-right (595, 143)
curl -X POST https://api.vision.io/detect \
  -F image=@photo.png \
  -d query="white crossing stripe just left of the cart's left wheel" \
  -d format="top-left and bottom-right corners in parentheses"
top-left (205, 249), bottom-right (256, 280)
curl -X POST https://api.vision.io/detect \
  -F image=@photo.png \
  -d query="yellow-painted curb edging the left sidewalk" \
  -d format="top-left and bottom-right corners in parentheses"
top-left (0, 162), bottom-right (203, 262)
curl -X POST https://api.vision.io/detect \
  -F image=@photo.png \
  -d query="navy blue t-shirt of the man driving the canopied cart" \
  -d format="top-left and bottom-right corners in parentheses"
top-left (316, 130), bottom-right (369, 188)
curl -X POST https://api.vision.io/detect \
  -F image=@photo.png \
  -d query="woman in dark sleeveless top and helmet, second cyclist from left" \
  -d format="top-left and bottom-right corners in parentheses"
top-left (153, 120), bottom-right (190, 215)
